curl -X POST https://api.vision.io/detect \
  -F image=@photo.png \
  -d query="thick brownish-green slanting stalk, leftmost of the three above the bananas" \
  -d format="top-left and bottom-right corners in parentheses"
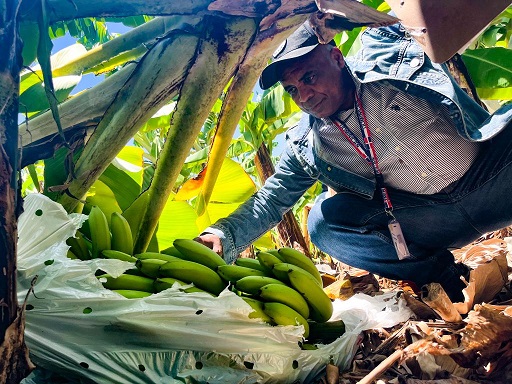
top-left (58, 32), bottom-right (198, 212)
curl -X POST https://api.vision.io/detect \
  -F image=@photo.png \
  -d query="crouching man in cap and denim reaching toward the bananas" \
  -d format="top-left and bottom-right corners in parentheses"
top-left (197, 18), bottom-right (512, 313)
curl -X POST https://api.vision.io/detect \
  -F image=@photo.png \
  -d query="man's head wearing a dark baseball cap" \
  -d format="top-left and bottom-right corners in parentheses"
top-left (260, 22), bottom-right (354, 118)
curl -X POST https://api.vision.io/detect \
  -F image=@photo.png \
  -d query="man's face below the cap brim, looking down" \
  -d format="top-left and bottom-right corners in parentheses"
top-left (281, 45), bottom-right (354, 118)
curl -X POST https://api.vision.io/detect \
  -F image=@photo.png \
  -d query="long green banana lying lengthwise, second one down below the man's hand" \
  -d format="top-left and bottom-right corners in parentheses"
top-left (160, 260), bottom-right (226, 295)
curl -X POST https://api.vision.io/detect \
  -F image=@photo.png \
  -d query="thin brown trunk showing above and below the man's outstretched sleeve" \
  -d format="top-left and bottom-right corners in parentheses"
top-left (254, 144), bottom-right (311, 257)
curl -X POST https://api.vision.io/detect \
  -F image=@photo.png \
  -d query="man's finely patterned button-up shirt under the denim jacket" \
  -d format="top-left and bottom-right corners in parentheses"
top-left (313, 83), bottom-right (479, 194)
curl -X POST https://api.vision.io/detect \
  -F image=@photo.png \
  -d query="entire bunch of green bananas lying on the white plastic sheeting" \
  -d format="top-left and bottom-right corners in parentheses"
top-left (68, 218), bottom-right (344, 342)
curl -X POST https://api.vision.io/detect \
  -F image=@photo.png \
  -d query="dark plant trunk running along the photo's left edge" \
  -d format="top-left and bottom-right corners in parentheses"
top-left (0, 0), bottom-right (33, 384)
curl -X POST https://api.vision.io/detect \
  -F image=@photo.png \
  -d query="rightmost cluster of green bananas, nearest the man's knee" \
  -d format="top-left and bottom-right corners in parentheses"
top-left (228, 247), bottom-right (333, 339)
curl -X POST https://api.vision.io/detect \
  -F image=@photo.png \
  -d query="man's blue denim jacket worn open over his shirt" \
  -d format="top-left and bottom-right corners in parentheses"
top-left (205, 24), bottom-right (512, 262)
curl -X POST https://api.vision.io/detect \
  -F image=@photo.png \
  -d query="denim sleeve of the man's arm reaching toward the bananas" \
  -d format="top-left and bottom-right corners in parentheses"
top-left (203, 145), bottom-right (316, 263)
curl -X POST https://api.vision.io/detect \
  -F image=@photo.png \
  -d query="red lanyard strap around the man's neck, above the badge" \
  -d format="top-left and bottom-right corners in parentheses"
top-left (332, 93), bottom-right (393, 216)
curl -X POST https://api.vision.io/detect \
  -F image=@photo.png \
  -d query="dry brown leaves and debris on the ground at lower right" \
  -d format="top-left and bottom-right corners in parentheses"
top-left (321, 228), bottom-right (512, 384)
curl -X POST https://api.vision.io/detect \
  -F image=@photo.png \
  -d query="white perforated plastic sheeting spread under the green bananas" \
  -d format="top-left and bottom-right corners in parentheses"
top-left (18, 194), bottom-right (412, 384)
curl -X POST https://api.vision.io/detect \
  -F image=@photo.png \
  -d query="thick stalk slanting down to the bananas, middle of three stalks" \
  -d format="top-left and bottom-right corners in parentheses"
top-left (134, 18), bottom-right (256, 252)
